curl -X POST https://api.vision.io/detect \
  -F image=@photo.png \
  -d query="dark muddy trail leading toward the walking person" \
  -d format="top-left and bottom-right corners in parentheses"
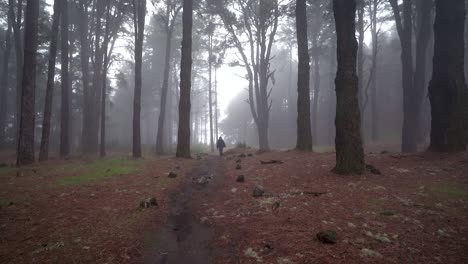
top-left (144, 156), bottom-right (230, 264)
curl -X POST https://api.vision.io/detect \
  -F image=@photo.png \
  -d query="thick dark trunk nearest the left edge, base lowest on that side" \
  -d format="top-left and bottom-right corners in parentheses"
top-left (16, 0), bottom-right (39, 166)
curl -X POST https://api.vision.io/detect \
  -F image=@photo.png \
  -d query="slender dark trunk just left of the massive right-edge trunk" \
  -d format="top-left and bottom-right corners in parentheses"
top-left (411, 0), bottom-right (434, 145)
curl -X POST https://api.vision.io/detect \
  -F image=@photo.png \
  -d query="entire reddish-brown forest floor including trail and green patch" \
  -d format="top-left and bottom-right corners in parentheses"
top-left (0, 149), bottom-right (468, 264)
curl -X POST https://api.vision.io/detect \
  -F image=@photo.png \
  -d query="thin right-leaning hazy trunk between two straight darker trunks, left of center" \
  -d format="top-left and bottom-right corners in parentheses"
top-left (156, 25), bottom-right (173, 155)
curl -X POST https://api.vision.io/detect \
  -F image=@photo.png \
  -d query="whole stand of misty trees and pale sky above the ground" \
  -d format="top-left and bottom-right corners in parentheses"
top-left (0, 0), bottom-right (468, 174)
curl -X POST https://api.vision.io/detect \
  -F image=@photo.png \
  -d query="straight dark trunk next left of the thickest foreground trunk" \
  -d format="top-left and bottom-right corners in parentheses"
top-left (296, 0), bottom-right (315, 151)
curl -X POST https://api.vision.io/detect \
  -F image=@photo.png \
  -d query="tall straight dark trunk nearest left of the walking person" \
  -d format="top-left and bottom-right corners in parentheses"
top-left (176, 0), bottom-right (193, 158)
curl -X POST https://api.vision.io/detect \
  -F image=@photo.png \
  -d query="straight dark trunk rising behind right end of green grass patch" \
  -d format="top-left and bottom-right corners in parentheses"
top-left (133, 0), bottom-right (146, 158)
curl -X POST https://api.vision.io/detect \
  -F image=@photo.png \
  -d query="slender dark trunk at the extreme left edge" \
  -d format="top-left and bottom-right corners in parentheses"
top-left (0, 10), bottom-right (12, 149)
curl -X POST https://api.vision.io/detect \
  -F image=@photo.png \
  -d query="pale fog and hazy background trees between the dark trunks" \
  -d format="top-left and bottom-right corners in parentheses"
top-left (0, 0), bottom-right (464, 161)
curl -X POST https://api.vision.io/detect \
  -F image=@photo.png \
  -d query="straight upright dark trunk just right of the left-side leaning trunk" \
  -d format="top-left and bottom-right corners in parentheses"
top-left (60, 0), bottom-right (70, 158)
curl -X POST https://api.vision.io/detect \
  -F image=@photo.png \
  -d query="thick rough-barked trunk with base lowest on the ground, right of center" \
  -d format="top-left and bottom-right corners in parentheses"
top-left (333, 0), bottom-right (365, 174)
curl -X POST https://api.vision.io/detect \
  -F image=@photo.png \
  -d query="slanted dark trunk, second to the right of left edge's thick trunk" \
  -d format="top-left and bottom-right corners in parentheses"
top-left (39, 0), bottom-right (62, 161)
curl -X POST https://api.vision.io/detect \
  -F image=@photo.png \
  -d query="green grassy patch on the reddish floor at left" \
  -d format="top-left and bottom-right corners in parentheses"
top-left (57, 157), bottom-right (143, 185)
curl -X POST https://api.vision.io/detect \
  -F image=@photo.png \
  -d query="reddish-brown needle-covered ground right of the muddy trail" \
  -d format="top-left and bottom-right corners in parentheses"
top-left (203, 151), bottom-right (468, 263)
